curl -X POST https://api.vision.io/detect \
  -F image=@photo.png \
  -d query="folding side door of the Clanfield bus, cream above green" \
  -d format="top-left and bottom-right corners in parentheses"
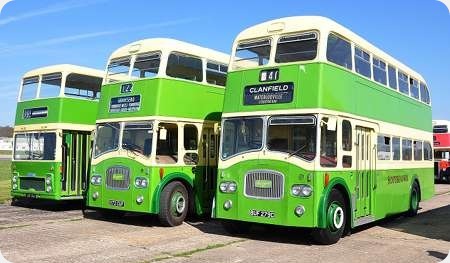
top-left (354, 126), bottom-right (376, 219)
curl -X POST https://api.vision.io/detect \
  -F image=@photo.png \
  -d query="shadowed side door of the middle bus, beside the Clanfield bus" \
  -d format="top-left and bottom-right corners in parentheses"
top-left (201, 127), bottom-right (218, 205)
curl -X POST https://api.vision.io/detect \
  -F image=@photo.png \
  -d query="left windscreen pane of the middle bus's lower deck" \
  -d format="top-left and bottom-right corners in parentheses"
top-left (94, 122), bottom-right (120, 157)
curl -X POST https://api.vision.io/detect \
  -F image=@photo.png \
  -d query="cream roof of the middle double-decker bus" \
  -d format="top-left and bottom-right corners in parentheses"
top-left (109, 38), bottom-right (230, 64)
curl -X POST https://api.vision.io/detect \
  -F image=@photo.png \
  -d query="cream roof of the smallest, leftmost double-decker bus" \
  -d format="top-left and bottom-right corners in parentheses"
top-left (23, 64), bottom-right (105, 79)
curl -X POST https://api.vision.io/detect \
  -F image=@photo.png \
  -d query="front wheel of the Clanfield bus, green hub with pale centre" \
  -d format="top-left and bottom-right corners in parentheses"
top-left (312, 189), bottom-right (347, 245)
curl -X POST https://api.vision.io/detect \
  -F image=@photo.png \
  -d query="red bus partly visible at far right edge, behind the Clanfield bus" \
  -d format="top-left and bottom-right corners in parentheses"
top-left (433, 120), bottom-right (450, 182)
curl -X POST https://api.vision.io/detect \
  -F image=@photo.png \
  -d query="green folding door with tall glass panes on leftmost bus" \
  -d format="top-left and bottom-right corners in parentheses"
top-left (61, 131), bottom-right (91, 196)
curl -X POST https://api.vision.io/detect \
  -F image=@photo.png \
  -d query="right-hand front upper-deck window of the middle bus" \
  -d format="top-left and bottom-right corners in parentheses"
top-left (131, 52), bottom-right (161, 78)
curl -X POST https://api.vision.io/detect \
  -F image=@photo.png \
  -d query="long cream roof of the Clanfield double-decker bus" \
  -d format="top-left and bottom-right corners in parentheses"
top-left (233, 16), bottom-right (426, 83)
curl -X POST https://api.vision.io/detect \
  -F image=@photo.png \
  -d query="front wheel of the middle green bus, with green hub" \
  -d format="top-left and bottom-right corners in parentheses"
top-left (158, 181), bottom-right (189, 226)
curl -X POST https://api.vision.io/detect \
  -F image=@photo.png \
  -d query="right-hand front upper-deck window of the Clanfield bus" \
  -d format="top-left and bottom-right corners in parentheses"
top-left (275, 32), bottom-right (318, 63)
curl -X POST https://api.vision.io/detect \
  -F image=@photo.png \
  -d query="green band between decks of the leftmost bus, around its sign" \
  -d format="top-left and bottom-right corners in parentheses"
top-left (15, 98), bottom-right (98, 126)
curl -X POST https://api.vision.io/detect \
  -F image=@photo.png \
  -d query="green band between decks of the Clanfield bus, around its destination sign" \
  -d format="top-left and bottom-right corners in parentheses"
top-left (223, 63), bottom-right (432, 132)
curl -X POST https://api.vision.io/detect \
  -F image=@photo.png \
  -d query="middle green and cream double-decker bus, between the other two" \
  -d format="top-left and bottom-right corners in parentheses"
top-left (87, 38), bottom-right (229, 226)
